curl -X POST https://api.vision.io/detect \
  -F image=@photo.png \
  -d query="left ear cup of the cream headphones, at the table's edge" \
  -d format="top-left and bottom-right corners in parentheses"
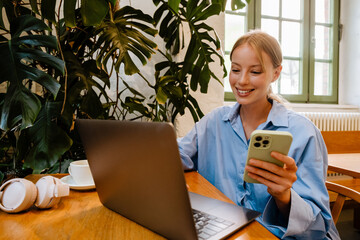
top-left (0, 178), bottom-right (37, 213)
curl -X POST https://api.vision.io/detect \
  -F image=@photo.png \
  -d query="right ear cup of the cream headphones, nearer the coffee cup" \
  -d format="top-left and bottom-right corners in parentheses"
top-left (35, 176), bottom-right (69, 208)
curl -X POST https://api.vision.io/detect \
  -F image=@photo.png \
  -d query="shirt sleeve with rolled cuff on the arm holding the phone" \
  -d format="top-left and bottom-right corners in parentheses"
top-left (263, 133), bottom-right (338, 239)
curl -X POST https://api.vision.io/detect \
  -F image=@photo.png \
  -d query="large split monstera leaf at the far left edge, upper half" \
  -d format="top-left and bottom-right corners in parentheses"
top-left (0, 15), bottom-right (64, 130)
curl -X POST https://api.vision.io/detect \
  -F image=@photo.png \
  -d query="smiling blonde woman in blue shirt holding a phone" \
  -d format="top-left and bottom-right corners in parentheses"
top-left (178, 30), bottom-right (339, 239)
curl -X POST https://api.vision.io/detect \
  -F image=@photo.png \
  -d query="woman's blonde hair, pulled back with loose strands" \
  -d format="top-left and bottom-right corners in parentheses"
top-left (230, 30), bottom-right (287, 103)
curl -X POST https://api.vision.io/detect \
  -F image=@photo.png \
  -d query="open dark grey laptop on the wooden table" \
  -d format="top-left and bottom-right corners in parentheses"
top-left (76, 119), bottom-right (260, 239)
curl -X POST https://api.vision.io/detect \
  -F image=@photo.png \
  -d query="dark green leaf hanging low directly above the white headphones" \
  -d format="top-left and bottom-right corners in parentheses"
top-left (24, 102), bottom-right (72, 173)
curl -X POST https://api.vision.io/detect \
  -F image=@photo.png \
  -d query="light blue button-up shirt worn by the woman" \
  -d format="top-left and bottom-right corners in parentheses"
top-left (178, 101), bottom-right (340, 239)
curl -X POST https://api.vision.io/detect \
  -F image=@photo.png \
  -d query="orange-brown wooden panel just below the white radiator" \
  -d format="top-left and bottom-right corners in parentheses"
top-left (321, 131), bottom-right (360, 154)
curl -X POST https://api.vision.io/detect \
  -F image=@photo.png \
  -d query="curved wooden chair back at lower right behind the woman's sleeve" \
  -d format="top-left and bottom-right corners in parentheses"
top-left (325, 181), bottom-right (360, 224)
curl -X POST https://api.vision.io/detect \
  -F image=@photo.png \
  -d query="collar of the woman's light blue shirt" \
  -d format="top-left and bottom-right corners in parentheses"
top-left (222, 100), bottom-right (289, 127)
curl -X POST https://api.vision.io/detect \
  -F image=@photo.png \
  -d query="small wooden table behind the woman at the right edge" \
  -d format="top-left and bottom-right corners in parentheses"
top-left (328, 153), bottom-right (360, 178)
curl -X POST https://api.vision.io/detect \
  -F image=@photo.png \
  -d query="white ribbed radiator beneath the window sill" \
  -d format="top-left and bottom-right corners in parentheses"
top-left (299, 112), bottom-right (360, 131)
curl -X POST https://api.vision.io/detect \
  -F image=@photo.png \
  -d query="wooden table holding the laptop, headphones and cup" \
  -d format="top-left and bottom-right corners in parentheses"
top-left (0, 172), bottom-right (277, 240)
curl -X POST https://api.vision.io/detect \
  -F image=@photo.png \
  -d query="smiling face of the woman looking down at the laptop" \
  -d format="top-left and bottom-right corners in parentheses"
top-left (229, 44), bottom-right (282, 105)
